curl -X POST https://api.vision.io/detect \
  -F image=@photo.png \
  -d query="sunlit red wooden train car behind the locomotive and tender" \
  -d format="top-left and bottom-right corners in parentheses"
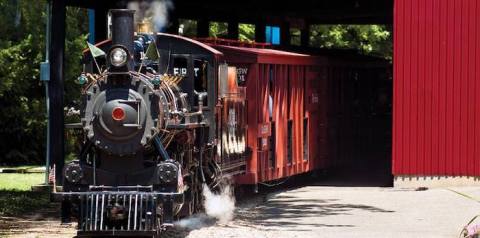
top-left (214, 45), bottom-right (327, 184)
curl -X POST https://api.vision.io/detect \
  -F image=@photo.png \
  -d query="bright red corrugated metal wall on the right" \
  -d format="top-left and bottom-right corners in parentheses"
top-left (393, 0), bottom-right (480, 176)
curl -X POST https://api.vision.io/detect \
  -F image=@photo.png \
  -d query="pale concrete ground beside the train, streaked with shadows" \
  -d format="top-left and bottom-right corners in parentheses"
top-left (188, 186), bottom-right (480, 238)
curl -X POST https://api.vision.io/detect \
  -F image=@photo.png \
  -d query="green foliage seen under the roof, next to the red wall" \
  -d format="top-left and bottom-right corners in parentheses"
top-left (310, 25), bottom-right (393, 60)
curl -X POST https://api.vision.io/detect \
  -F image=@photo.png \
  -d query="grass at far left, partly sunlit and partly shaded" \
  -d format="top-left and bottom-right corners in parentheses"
top-left (0, 173), bottom-right (50, 216)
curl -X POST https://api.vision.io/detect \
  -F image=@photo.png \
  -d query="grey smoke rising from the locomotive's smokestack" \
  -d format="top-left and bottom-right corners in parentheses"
top-left (128, 0), bottom-right (173, 32)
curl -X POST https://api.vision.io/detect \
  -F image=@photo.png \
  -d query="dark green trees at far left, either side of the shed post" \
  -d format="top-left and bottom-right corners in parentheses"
top-left (0, 0), bottom-right (88, 165)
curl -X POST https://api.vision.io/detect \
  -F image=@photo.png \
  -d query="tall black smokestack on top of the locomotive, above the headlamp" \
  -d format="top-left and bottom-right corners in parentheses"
top-left (110, 9), bottom-right (135, 58)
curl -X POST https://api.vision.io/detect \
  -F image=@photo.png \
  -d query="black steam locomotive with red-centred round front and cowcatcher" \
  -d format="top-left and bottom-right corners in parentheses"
top-left (56, 9), bottom-right (232, 237)
